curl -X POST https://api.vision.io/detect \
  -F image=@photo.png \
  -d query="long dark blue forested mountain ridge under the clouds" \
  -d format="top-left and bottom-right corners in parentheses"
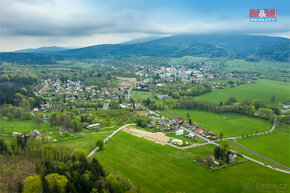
top-left (0, 34), bottom-right (290, 64)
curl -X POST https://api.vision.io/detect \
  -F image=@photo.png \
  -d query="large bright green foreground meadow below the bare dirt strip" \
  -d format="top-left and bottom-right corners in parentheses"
top-left (96, 131), bottom-right (289, 193)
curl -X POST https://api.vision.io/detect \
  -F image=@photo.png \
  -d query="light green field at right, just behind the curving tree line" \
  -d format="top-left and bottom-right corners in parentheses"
top-left (197, 79), bottom-right (290, 105)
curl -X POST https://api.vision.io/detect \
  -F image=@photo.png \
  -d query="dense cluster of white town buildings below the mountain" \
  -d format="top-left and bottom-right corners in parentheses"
top-left (134, 63), bottom-right (256, 91)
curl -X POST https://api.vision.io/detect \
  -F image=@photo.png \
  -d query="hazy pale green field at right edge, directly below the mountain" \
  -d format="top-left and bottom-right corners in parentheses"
top-left (224, 59), bottom-right (290, 77)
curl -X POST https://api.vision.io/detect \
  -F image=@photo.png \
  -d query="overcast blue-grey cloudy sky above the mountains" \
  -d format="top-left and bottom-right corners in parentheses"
top-left (0, 0), bottom-right (290, 51)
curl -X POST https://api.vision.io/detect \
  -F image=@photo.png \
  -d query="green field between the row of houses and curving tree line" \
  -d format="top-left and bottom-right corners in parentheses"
top-left (164, 109), bottom-right (271, 137)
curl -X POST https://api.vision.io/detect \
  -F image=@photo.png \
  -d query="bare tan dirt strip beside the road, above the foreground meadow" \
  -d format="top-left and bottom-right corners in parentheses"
top-left (124, 128), bottom-right (170, 145)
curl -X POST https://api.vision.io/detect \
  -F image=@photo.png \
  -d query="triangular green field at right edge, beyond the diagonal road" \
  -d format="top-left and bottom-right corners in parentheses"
top-left (238, 125), bottom-right (290, 167)
